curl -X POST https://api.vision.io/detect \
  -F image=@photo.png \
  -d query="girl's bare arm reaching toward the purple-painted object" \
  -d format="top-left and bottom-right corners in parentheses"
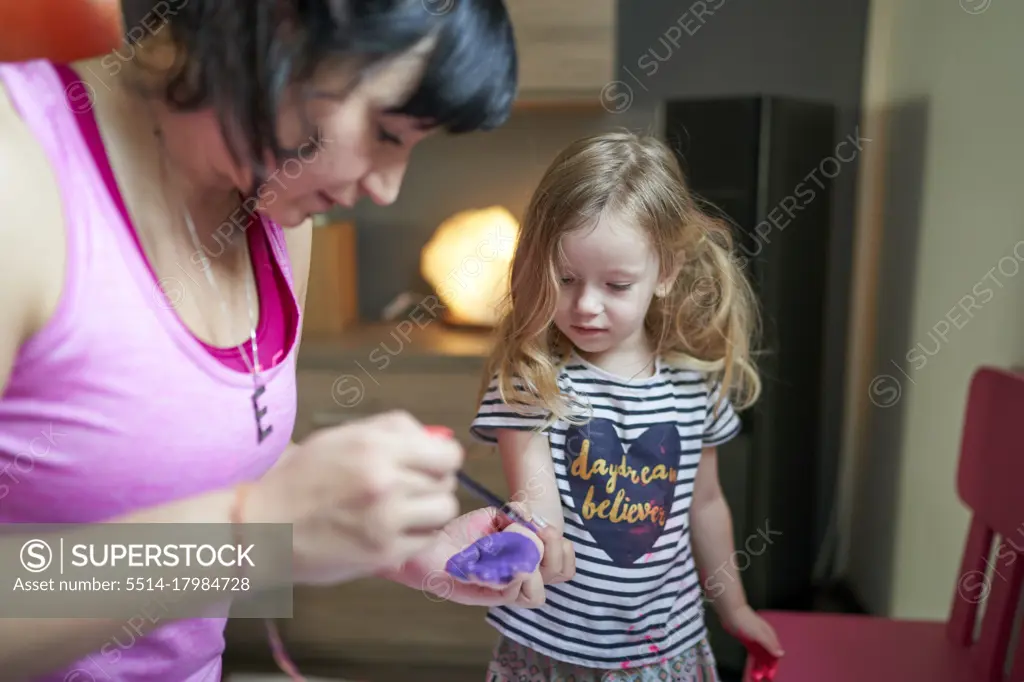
top-left (497, 429), bottom-right (575, 585)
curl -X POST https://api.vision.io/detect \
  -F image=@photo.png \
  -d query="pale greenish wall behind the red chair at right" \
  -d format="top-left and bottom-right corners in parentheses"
top-left (844, 0), bottom-right (1024, 620)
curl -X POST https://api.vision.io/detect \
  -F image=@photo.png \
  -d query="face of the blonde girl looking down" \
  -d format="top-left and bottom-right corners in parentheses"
top-left (555, 212), bottom-right (660, 354)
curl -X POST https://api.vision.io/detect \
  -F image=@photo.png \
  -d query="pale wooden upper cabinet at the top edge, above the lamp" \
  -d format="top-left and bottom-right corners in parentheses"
top-left (506, 0), bottom-right (616, 103)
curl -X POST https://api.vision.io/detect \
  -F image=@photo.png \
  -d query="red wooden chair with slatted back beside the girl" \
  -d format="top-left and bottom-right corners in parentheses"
top-left (743, 367), bottom-right (1024, 682)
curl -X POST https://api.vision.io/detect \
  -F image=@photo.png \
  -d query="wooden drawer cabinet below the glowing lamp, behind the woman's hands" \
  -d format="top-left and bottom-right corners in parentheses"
top-left (228, 322), bottom-right (507, 670)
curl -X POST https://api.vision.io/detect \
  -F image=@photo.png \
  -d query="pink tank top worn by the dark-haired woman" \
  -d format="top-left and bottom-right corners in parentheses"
top-left (0, 61), bottom-right (301, 682)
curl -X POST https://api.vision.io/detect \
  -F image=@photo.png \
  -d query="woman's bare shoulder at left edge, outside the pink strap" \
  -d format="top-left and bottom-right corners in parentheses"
top-left (0, 76), bottom-right (65, 348)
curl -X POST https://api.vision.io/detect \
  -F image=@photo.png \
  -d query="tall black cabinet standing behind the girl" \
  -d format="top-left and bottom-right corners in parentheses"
top-left (664, 96), bottom-right (835, 670)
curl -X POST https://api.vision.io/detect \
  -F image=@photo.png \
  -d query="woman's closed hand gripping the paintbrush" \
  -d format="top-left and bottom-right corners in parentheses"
top-left (250, 412), bottom-right (464, 584)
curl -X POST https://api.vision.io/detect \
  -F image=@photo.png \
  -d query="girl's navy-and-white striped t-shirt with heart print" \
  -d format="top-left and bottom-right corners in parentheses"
top-left (471, 353), bottom-right (740, 669)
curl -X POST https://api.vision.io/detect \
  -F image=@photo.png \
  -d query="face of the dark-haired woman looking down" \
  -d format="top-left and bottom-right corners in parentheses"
top-left (251, 45), bottom-right (440, 227)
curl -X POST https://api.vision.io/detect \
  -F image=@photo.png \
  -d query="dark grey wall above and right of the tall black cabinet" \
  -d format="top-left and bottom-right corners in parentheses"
top-left (614, 0), bottom-right (868, 565)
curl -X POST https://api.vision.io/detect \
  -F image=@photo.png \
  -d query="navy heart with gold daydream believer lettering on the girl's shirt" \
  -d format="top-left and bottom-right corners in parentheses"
top-left (565, 419), bottom-right (680, 566)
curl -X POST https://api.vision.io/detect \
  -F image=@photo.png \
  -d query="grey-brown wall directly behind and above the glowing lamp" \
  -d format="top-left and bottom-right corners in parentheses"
top-left (323, 106), bottom-right (651, 319)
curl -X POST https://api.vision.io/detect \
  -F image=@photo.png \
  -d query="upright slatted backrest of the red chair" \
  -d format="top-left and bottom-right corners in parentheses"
top-left (948, 367), bottom-right (1024, 682)
